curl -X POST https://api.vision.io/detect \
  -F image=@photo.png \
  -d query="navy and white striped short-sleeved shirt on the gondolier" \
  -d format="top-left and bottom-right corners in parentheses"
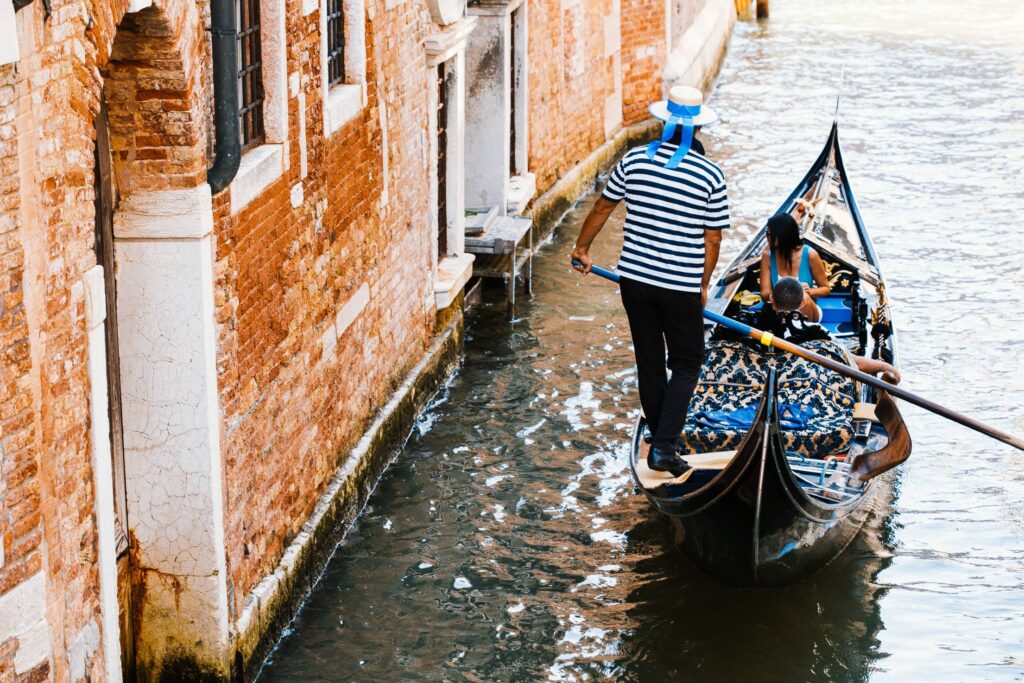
top-left (602, 142), bottom-right (729, 293)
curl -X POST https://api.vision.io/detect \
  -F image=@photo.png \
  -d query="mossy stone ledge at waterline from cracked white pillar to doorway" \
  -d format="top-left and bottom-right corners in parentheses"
top-left (231, 313), bottom-right (464, 681)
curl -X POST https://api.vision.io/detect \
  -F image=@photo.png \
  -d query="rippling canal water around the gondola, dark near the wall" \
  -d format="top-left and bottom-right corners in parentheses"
top-left (261, 0), bottom-right (1024, 682)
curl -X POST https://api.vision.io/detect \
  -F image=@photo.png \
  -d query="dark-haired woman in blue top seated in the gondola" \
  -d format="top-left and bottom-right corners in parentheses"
top-left (761, 213), bottom-right (831, 323)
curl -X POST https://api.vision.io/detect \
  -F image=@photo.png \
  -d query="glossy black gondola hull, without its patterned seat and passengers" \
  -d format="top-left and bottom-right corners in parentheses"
top-left (631, 123), bottom-right (910, 586)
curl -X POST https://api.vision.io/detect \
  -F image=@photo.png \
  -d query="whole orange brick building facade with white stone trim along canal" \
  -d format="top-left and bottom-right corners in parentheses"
top-left (0, 0), bottom-right (734, 681)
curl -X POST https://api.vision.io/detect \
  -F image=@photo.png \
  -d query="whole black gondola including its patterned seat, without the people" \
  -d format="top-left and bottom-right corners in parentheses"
top-left (631, 124), bottom-right (910, 586)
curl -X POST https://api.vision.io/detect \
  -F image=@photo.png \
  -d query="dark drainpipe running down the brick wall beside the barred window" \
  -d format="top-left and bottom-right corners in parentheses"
top-left (206, 0), bottom-right (242, 195)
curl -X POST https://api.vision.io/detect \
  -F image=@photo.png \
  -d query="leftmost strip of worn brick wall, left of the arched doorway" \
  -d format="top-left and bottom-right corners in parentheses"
top-left (0, 2), bottom-right (134, 681)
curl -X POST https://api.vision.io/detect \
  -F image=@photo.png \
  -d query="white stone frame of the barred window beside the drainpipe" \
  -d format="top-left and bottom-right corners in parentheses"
top-left (230, 0), bottom-right (288, 215)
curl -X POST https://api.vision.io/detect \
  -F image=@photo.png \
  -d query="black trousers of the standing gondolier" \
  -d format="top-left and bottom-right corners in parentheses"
top-left (618, 278), bottom-right (705, 450)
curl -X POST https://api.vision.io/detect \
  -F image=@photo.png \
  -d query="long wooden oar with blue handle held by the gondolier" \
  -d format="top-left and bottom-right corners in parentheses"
top-left (572, 259), bottom-right (1024, 451)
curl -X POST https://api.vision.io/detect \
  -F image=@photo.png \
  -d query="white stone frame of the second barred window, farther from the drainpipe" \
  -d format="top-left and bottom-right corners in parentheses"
top-left (319, 0), bottom-right (367, 138)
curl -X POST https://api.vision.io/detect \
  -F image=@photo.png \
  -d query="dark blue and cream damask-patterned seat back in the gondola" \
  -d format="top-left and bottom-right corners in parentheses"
top-left (682, 341), bottom-right (856, 458)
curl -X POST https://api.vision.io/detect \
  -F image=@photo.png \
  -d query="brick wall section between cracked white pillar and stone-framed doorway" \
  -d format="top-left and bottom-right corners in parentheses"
top-left (217, 0), bottom-right (435, 608)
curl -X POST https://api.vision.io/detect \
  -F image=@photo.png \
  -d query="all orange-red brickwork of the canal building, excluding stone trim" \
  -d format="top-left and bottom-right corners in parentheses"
top-left (0, 0), bottom-right (729, 681)
